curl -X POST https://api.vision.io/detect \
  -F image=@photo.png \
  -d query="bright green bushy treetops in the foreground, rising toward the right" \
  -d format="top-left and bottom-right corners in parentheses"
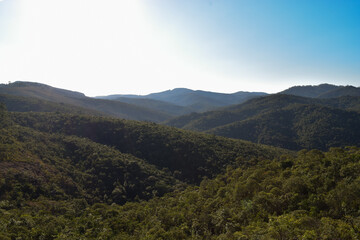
top-left (0, 148), bottom-right (360, 239)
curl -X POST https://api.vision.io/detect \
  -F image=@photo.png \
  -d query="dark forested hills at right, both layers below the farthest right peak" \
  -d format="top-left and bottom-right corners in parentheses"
top-left (165, 94), bottom-right (360, 150)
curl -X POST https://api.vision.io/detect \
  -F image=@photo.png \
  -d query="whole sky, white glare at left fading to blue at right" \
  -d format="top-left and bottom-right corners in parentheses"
top-left (0, 0), bottom-right (360, 96)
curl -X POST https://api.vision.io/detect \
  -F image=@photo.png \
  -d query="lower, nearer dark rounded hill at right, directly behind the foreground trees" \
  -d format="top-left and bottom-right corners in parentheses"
top-left (207, 105), bottom-right (360, 150)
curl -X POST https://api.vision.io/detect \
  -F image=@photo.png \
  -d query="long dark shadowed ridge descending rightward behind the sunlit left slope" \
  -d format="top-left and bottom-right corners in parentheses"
top-left (11, 110), bottom-right (283, 183)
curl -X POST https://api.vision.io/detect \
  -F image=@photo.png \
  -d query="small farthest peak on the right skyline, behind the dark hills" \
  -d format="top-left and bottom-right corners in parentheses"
top-left (280, 84), bottom-right (360, 98)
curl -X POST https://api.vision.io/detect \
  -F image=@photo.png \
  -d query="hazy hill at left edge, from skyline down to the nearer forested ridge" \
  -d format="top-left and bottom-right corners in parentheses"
top-left (0, 82), bottom-right (171, 122)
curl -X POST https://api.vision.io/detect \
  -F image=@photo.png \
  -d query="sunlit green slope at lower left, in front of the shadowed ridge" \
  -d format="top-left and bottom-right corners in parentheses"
top-left (0, 105), bottom-right (183, 203)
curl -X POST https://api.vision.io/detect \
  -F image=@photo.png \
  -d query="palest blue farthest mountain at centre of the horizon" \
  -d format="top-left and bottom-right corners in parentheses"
top-left (98, 88), bottom-right (267, 112)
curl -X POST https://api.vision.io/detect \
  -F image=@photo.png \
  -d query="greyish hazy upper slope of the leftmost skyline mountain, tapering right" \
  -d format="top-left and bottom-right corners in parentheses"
top-left (0, 82), bottom-right (172, 122)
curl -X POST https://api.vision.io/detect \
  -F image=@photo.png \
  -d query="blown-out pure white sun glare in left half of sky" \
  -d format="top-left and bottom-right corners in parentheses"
top-left (7, 0), bottom-right (194, 94)
